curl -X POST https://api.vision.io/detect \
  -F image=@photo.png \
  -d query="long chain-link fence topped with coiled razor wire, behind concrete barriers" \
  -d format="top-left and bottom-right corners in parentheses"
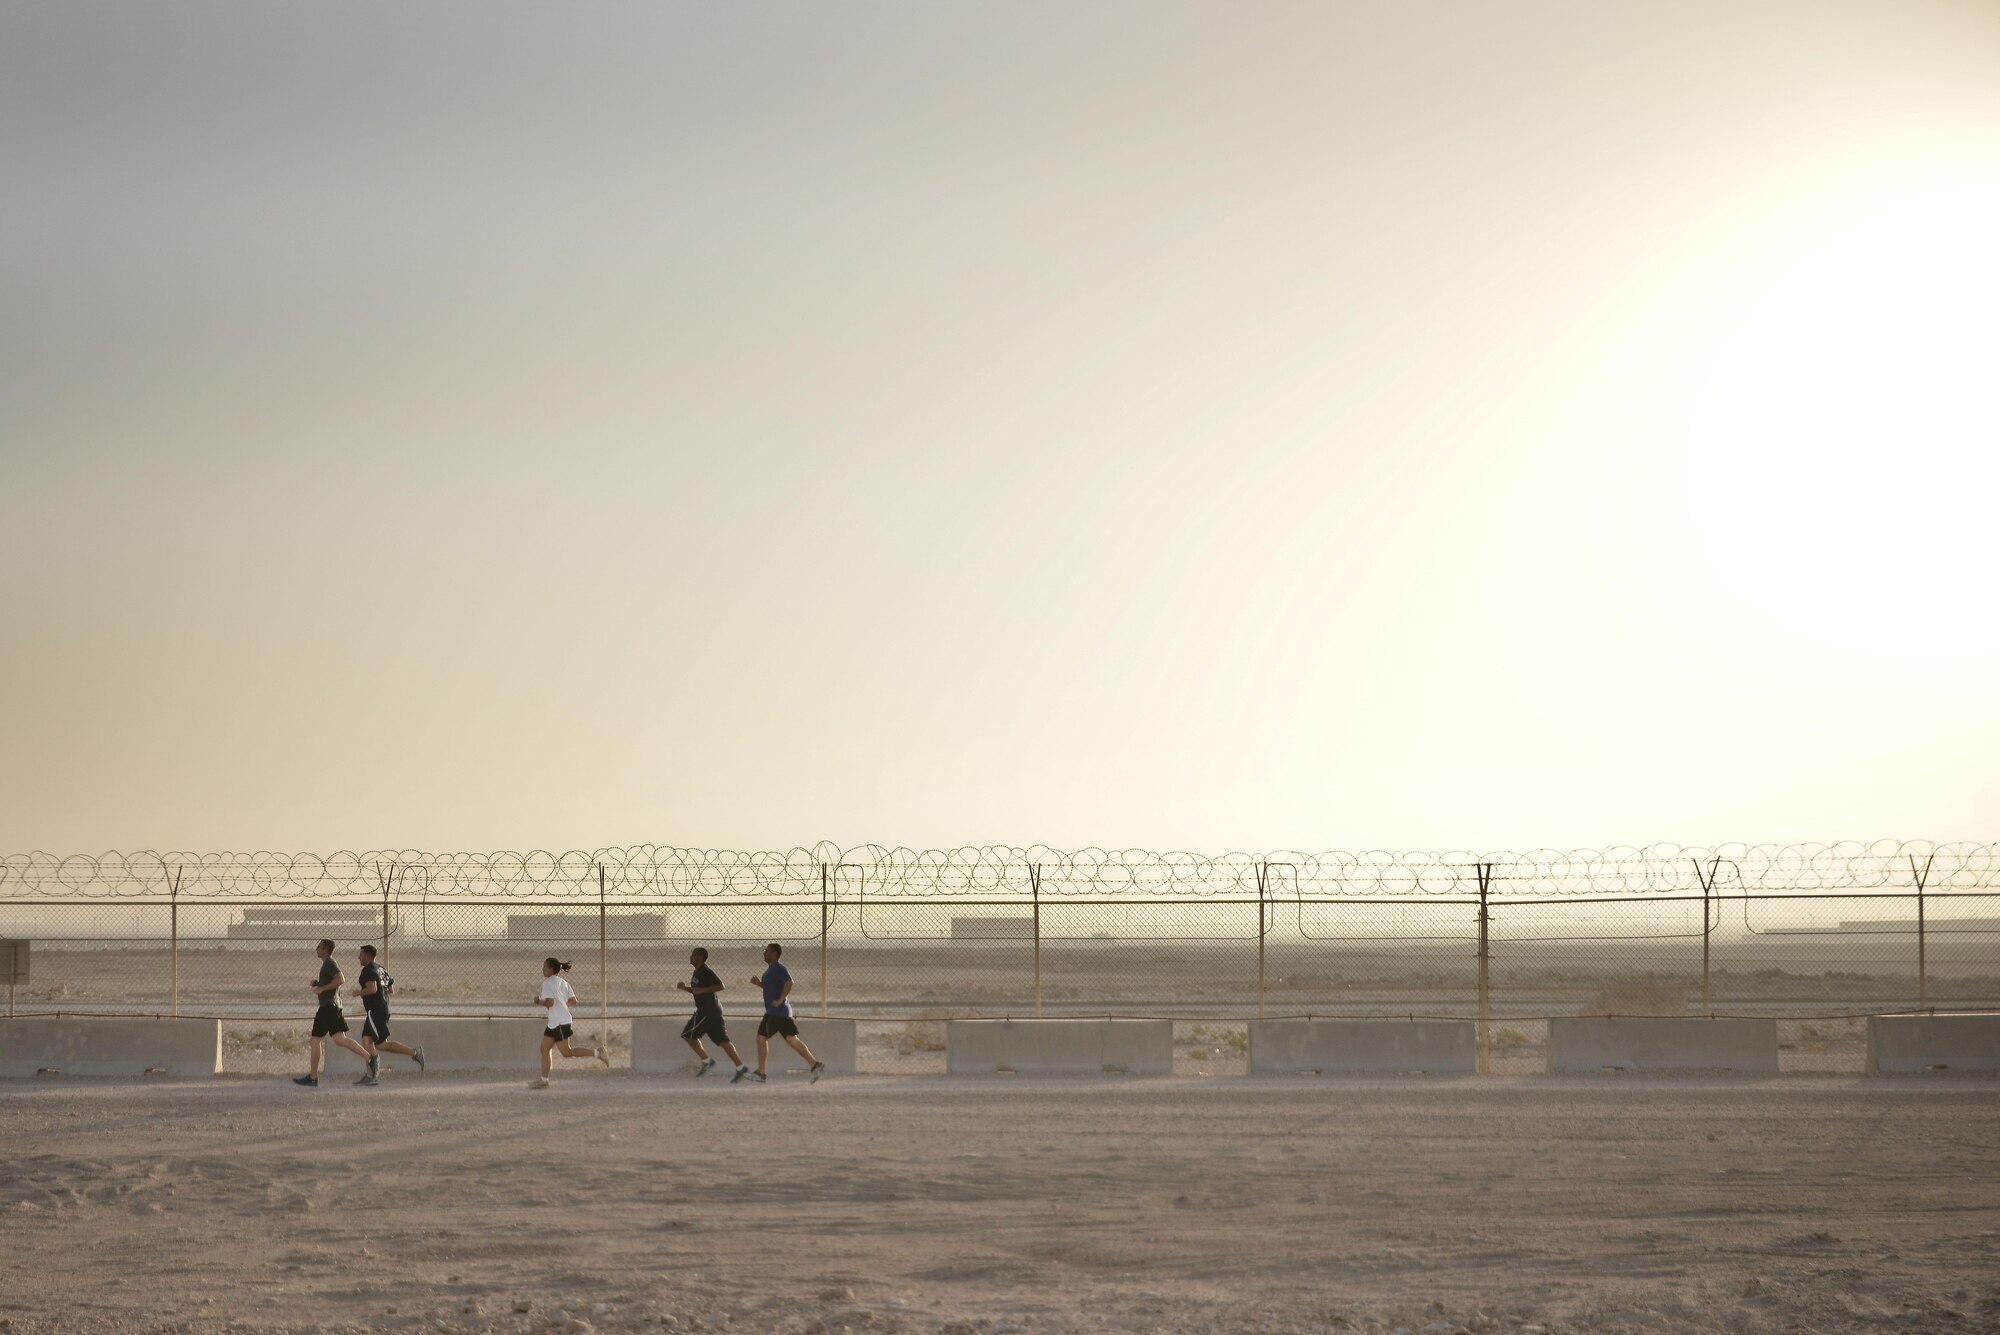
top-left (0, 843), bottom-right (2000, 1073)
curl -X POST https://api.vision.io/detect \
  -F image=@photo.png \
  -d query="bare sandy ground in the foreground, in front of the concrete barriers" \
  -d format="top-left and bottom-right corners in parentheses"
top-left (0, 1069), bottom-right (2000, 1335)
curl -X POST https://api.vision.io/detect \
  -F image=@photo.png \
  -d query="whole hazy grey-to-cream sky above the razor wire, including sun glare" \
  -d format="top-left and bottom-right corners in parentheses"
top-left (0, 0), bottom-right (2000, 851)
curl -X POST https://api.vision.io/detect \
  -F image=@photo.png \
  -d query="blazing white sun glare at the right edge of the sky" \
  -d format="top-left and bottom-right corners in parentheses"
top-left (1690, 172), bottom-right (2000, 655)
